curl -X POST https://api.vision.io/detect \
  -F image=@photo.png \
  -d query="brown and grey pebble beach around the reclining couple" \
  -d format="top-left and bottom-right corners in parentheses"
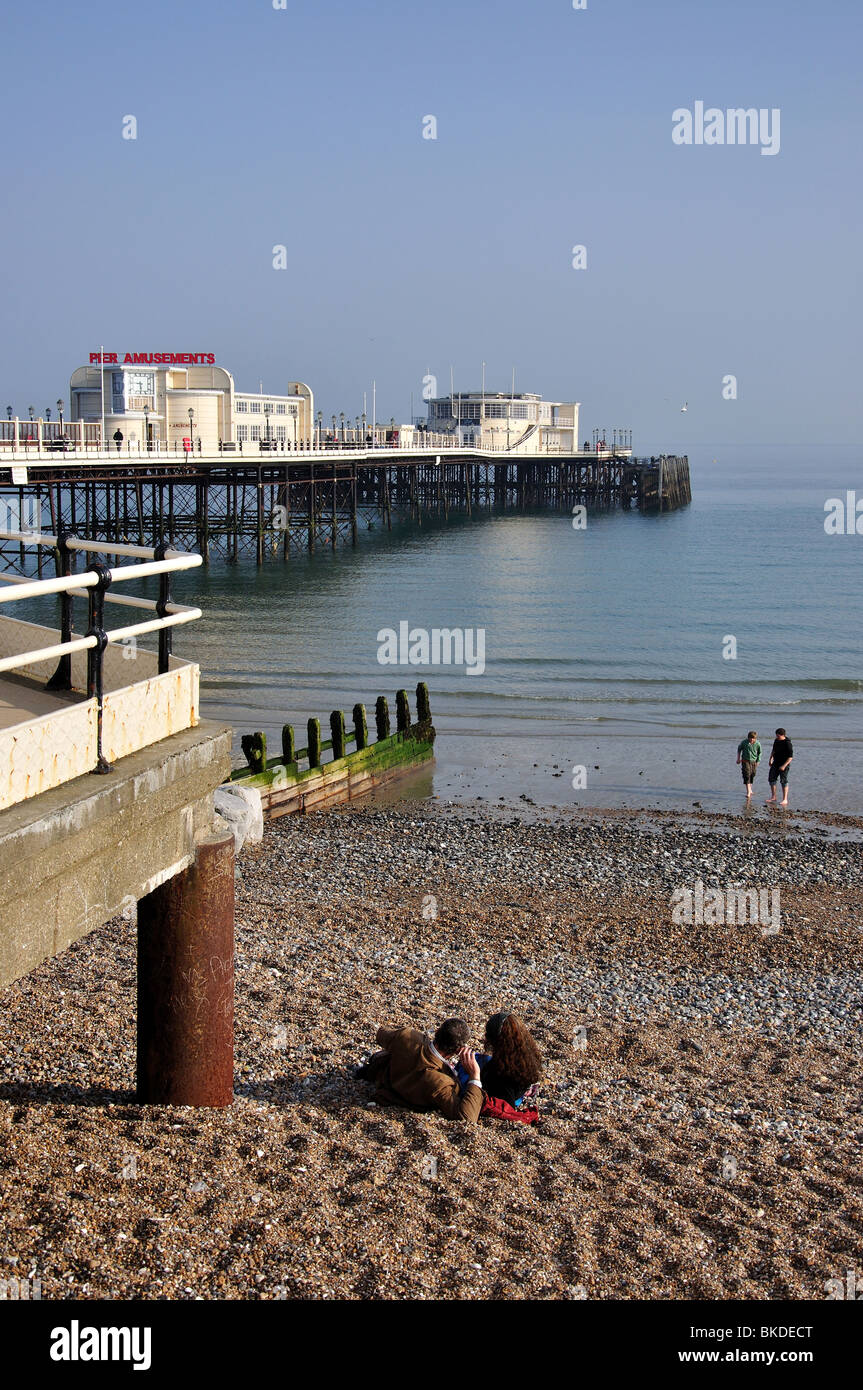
top-left (0, 802), bottom-right (863, 1300)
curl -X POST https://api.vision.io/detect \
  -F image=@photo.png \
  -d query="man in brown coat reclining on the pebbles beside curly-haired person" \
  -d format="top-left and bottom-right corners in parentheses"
top-left (357, 1019), bottom-right (482, 1122)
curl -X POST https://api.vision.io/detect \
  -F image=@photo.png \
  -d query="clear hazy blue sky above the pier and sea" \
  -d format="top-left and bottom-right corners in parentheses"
top-left (0, 0), bottom-right (863, 449)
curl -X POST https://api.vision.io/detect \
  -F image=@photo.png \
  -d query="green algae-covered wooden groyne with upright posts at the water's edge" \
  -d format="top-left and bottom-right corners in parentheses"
top-left (229, 681), bottom-right (435, 819)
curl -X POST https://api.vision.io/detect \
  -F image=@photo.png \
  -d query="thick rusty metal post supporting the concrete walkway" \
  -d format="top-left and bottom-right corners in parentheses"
top-left (138, 834), bottom-right (233, 1106)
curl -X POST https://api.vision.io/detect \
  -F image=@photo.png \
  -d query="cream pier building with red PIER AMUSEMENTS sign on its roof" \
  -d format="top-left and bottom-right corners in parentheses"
top-left (69, 352), bottom-right (314, 453)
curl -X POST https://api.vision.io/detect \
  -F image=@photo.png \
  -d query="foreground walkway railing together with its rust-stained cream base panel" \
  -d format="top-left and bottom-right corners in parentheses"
top-left (0, 531), bottom-right (202, 806)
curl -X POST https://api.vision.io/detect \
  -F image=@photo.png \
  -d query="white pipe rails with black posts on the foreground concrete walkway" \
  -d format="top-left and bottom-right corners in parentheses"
top-left (0, 531), bottom-right (203, 771)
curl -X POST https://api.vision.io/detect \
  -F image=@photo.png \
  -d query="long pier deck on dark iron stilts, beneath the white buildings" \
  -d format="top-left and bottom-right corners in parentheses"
top-left (0, 441), bottom-right (691, 573)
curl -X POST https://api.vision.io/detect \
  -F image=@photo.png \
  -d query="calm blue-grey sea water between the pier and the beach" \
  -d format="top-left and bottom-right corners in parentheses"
top-left (168, 445), bottom-right (863, 812)
